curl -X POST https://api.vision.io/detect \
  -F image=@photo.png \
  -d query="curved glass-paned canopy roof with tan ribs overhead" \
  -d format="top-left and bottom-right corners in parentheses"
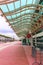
top-left (0, 0), bottom-right (43, 37)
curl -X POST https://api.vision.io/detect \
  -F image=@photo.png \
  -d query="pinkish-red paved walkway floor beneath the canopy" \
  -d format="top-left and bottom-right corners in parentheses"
top-left (0, 41), bottom-right (40, 65)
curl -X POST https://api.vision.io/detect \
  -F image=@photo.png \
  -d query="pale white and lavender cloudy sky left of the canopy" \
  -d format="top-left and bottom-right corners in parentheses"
top-left (0, 16), bottom-right (19, 40)
